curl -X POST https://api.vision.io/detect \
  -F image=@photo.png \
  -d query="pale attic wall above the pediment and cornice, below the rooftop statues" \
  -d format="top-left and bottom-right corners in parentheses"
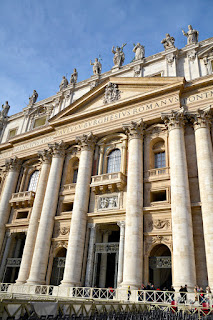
top-left (0, 38), bottom-right (213, 143)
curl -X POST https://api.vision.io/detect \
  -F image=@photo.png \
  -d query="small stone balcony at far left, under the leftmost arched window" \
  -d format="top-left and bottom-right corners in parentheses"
top-left (9, 191), bottom-right (35, 208)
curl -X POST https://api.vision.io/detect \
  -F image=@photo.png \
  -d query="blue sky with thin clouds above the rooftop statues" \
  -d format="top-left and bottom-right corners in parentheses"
top-left (0, 0), bottom-right (213, 114)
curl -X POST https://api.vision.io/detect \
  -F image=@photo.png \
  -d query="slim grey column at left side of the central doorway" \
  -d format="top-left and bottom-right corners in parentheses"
top-left (85, 223), bottom-right (96, 287)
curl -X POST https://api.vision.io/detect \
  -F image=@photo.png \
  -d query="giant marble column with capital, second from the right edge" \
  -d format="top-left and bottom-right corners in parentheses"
top-left (162, 109), bottom-right (196, 290)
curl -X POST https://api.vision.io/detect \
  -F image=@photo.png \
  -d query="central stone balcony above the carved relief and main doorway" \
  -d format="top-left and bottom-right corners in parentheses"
top-left (90, 172), bottom-right (126, 194)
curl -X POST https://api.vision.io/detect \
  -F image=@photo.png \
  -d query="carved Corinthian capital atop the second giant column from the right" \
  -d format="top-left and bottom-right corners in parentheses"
top-left (161, 108), bottom-right (186, 131)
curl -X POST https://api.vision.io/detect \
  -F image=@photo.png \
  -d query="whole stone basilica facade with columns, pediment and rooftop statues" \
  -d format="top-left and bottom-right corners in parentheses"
top-left (0, 26), bottom-right (213, 289)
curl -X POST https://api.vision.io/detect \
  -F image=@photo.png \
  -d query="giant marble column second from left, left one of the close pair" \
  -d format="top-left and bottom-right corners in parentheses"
top-left (16, 150), bottom-right (51, 284)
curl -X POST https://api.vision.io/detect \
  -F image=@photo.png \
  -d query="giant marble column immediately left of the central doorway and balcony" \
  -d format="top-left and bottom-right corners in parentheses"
top-left (61, 133), bottom-right (96, 286)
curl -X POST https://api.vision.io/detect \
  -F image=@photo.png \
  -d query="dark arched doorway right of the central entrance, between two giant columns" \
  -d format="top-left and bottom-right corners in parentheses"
top-left (149, 244), bottom-right (172, 290)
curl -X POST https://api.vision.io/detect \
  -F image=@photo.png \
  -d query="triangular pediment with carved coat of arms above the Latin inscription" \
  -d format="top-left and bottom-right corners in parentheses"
top-left (50, 77), bottom-right (185, 124)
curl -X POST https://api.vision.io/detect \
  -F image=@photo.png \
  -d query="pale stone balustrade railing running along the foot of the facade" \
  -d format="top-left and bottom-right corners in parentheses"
top-left (0, 283), bottom-right (213, 309)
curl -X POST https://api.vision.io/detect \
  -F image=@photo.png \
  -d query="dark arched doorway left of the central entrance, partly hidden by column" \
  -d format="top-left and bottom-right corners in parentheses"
top-left (50, 248), bottom-right (67, 286)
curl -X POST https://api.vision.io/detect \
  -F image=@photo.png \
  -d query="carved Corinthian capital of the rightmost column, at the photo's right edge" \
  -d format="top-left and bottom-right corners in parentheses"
top-left (190, 107), bottom-right (213, 130)
